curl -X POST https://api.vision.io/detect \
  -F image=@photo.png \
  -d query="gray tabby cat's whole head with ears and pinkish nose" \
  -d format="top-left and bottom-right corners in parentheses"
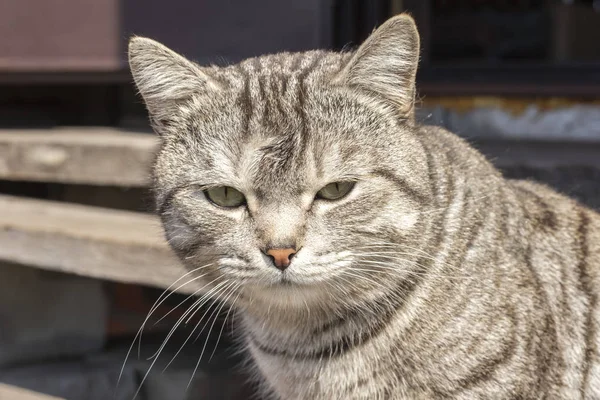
top-left (129, 15), bottom-right (431, 307)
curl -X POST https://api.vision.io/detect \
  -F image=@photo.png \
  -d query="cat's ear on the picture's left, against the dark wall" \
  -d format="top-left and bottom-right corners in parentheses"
top-left (129, 37), bottom-right (218, 134)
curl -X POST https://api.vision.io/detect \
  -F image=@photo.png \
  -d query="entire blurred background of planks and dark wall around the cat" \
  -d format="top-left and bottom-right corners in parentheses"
top-left (0, 0), bottom-right (600, 400)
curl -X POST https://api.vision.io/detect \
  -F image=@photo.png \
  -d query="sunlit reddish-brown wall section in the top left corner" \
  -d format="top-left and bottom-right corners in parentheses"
top-left (0, 0), bottom-right (121, 72)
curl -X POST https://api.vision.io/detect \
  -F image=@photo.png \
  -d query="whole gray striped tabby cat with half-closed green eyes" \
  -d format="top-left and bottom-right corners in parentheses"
top-left (129, 15), bottom-right (600, 400)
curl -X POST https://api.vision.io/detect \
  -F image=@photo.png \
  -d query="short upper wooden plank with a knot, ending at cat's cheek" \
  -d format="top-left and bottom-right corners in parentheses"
top-left (0, 128), bottom-right (158, 187)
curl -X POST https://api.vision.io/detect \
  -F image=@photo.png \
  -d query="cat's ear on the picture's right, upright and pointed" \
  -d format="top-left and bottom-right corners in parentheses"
top-left (335, 14), bottom-right (419, 119)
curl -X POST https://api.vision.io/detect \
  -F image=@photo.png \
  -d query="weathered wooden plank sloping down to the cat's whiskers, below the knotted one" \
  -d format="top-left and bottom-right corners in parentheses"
top-left (0, 195), bottom-right (196, 293)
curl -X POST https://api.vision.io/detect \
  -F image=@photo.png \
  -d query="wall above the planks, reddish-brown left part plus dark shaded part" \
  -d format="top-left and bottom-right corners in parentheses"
top-left (0, 0), bottom-right (331, 73)
